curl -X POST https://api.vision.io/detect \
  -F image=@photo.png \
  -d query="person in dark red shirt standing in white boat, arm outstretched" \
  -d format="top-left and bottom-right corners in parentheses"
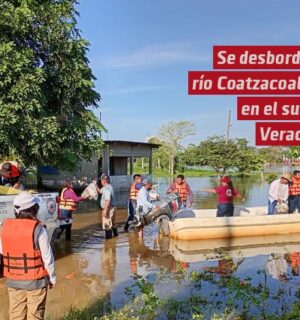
top-left (201, 176), bottom-right (245, 217)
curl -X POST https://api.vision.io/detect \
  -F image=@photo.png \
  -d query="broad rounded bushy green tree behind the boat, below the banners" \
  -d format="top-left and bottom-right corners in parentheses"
top-left (184, 136), bottom-right (263, 174)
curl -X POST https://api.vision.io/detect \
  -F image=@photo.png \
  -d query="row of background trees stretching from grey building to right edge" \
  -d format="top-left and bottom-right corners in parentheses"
top-left (148, 121), bottom-right (300, 175)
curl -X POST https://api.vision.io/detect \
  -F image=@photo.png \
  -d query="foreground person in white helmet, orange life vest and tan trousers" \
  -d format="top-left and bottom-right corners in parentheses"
top-left (0, 191), bottom-right (56, 320)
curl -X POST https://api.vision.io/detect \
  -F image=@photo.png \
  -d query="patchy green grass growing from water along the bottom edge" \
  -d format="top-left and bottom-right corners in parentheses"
top-left (56, 270), bottom-right (300, 320)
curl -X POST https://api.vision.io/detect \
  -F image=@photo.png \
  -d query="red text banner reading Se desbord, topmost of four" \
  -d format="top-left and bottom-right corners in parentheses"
top-left (213, 46), bottom-right (300, 69)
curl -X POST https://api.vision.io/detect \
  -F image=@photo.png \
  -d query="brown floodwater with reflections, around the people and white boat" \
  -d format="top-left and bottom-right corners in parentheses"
top-left (0, 178), bottom-right (300, 319)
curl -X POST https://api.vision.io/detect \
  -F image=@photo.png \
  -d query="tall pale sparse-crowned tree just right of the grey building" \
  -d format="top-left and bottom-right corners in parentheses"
top-left (157, 121), bottom-right (195, 176)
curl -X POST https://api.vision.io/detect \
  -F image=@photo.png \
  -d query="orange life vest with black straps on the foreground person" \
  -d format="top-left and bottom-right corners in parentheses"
top-left (2, 219), bottom-right (48, 280)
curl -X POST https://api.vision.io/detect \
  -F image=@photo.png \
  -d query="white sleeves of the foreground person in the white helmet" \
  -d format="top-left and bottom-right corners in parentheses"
top-left (0, 222), bottom-right (56, 284)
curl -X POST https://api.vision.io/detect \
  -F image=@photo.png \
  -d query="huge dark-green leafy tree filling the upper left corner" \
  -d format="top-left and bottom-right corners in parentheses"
top-left (0, 0), bottom-right (105, 170)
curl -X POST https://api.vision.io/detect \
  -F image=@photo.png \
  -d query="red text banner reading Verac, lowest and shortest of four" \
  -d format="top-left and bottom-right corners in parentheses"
top-left (255, 122), bottom-right (300, 146)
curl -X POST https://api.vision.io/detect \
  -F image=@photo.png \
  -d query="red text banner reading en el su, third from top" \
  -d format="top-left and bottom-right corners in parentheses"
top-left (237, 96), bottom-right (300, 120)
